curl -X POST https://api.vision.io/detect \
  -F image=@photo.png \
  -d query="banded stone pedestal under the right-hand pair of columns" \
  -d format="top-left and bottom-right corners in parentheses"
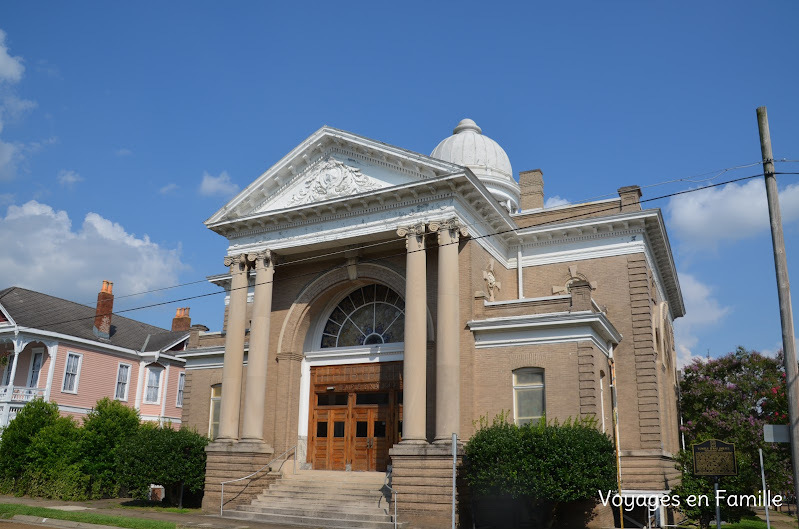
top-left (389, 443), bottom-right (471, 529)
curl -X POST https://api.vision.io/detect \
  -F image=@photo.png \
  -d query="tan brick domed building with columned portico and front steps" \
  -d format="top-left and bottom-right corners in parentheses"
top-left (180, 119), bottom-right (685, 527)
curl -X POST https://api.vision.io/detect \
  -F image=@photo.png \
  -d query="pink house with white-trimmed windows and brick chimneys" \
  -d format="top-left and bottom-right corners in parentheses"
top-left (0, 281), bottom-right (191, 428)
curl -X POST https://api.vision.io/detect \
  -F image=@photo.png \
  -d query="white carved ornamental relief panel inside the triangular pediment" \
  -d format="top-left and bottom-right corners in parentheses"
top-left (286, 156), bottom-right (384, 206)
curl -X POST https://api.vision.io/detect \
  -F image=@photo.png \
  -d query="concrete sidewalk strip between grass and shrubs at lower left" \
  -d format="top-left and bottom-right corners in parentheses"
top-left (0, 494), bottom-right (297, 529)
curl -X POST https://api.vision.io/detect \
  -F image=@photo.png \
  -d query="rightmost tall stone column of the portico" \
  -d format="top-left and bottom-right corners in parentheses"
top-left (430, 218), bottom-right (468, 443)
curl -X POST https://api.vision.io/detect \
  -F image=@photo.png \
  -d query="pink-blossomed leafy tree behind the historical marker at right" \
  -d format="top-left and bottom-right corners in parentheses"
top-left (674, 347), bottom-right (793, 528)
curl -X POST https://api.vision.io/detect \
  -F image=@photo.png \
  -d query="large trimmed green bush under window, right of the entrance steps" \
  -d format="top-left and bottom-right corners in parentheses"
top-left (465, 414), bottom-right (616, 526)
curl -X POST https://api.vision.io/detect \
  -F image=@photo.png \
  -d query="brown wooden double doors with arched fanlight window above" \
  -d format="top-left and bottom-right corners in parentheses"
top-left (308, 283), bottom-right (405, 471)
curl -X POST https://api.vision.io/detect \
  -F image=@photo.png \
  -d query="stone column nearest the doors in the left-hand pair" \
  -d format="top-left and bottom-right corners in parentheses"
top-left (241, 250), bottom-right (275, 442)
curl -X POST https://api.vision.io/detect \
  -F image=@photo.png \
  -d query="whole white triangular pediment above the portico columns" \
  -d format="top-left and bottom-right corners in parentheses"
top-left (205, 127), bottom-right (463, 227)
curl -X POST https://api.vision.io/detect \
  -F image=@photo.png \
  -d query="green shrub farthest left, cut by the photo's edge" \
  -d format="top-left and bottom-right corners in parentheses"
top-left (0, 399), bottom-right (59, 483)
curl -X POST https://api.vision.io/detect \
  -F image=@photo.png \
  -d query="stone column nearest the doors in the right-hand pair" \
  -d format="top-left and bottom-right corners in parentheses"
top-left (397, 224), bottom-right (427, 444)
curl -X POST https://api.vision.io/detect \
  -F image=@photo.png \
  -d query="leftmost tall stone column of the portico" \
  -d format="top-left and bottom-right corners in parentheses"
top-left (217, 254), bottom-right (249, 441)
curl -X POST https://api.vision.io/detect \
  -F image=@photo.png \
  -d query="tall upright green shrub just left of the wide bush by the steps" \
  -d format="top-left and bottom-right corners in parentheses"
top-left (80, 397), bottom-right (139, 497)
